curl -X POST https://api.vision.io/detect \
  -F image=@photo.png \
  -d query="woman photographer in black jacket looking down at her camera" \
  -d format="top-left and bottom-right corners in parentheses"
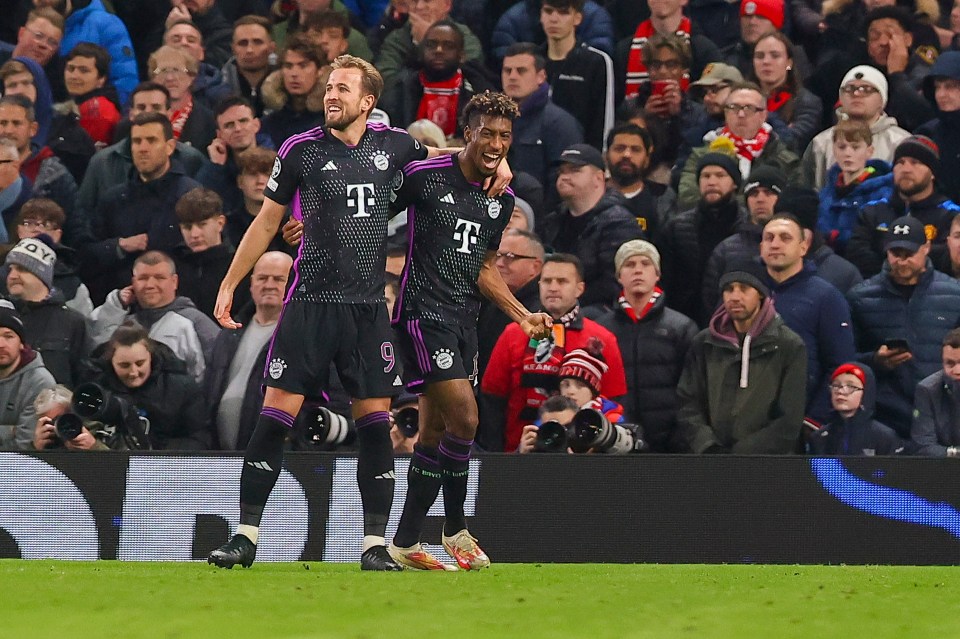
top-left (81, 322), bottom-right (211, 450)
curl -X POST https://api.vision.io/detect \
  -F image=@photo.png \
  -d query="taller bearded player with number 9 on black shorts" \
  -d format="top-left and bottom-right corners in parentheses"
top-left (208, 55), bottom-right (510, 570)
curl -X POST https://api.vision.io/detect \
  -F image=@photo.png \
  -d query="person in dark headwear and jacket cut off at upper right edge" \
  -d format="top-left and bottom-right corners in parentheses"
top-left (916, 51), bottom-right (960, 202)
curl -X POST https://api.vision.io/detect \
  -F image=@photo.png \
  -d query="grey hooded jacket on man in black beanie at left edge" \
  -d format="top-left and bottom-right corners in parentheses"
top-left (0, 346), bottom-right (57, 450)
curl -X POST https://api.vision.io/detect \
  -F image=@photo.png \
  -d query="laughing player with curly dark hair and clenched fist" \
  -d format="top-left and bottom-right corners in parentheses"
top-left (389, 91), bottom-right (551, 570)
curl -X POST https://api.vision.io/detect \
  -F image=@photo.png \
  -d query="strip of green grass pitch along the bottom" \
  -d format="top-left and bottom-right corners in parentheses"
top-left (0, 560), bottom-right (960, 639)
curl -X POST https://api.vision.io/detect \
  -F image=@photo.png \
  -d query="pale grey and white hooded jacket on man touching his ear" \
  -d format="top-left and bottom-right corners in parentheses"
top-left (89, 291), bottom-right (220, 382)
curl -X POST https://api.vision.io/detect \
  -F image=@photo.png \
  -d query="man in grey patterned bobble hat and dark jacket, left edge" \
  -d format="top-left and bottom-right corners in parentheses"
top-left (4, 236), bottom-right (87, 388)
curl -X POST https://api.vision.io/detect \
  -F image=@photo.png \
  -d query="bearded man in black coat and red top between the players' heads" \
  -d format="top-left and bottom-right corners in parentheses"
top-left (379, 19), bottom-right (494, 138)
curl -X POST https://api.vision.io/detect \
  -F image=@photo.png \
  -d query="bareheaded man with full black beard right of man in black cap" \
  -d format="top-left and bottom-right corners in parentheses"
top-left (604, 122), bottom-right (676, 237)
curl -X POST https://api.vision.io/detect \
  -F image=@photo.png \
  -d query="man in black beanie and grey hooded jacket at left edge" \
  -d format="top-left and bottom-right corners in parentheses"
top-left (0, 300), bottom-right (56, 450)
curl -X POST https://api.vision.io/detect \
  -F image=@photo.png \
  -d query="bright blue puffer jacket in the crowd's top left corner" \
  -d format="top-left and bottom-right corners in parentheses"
top-left (60, 0), bottom-right (139, 105)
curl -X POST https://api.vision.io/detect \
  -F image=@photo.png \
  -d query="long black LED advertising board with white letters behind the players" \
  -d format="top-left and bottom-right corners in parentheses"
top-left (0, 452), bottom-right (960, 565)
